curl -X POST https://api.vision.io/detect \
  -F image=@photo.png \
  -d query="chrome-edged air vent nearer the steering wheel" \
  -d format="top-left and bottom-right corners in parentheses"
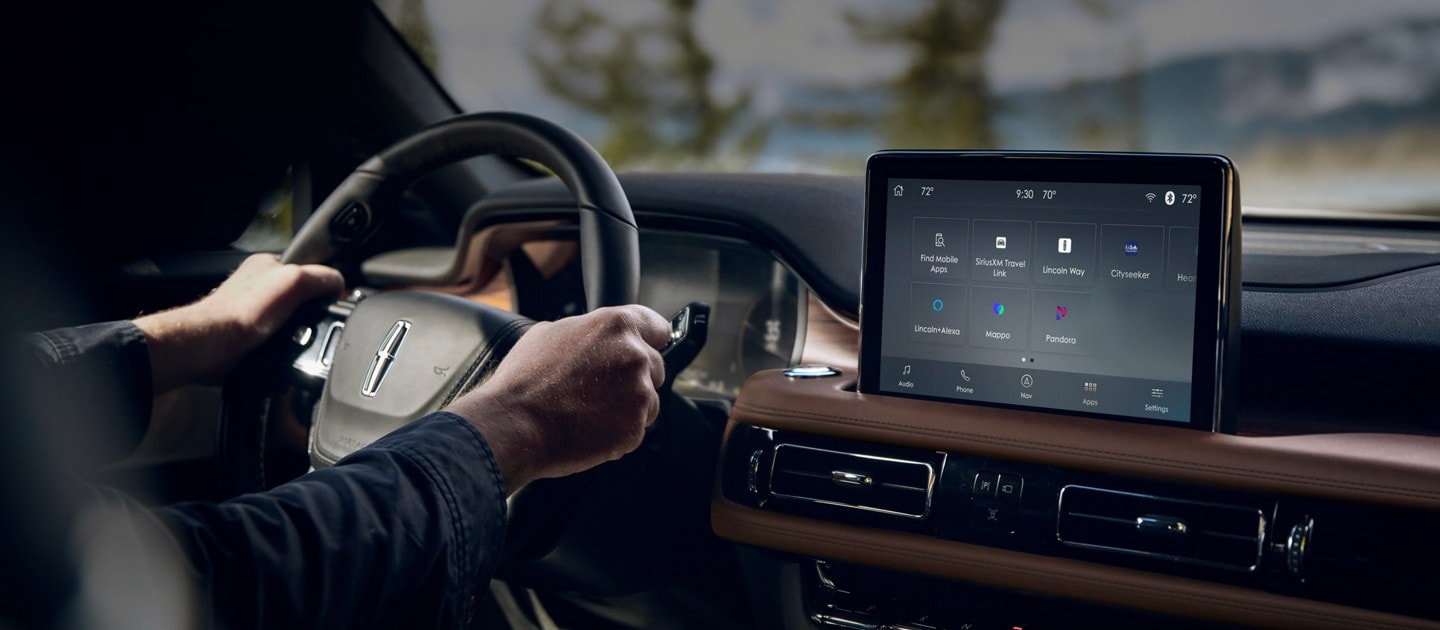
top-left (770, 444), bottom-right (935, 519)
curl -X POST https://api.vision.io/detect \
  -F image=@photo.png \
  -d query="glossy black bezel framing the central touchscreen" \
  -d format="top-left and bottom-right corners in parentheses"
top-left (857, 151), bottom-right (1240, 433)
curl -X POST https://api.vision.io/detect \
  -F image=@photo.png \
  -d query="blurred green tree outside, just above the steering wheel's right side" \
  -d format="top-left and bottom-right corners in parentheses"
top-left (527, 0), bottom-right (768, 165)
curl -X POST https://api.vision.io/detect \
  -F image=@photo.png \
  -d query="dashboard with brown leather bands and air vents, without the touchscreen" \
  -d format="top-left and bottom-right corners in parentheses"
top-left (463, 174), bottom-right (1440, 629)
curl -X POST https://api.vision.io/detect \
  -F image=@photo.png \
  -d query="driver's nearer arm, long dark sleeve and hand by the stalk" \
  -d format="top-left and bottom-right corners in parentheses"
top-left (143, 306), bottom-right (668, 627)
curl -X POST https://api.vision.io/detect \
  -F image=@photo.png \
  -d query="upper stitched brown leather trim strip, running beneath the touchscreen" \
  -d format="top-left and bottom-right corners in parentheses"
top-left (732, 373), bottom-right (1440, 509)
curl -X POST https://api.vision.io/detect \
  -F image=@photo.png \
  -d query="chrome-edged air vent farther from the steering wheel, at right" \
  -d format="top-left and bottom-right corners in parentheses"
top-left (1056, 486), bottom-right (1266, 571)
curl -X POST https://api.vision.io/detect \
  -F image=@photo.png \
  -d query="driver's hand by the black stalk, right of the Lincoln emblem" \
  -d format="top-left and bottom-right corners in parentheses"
top-left (446, 305), bottom-right (670, 492)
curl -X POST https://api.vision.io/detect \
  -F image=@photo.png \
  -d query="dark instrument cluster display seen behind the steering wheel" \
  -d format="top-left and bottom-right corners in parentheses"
top-left (464, 222), bottom-right (809, 400)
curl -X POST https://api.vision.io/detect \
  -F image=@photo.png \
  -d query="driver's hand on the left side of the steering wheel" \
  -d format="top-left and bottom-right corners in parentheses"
top-left (135, 253), bottom-right (346, 396)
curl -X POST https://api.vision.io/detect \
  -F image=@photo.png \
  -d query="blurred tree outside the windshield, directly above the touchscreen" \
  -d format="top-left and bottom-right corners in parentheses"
top-left (816, 0), bottom-right (1005, 148)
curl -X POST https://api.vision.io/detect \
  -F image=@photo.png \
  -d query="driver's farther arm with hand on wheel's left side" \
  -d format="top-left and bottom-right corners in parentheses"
top-left (22, 255), bottom-right (344, 467)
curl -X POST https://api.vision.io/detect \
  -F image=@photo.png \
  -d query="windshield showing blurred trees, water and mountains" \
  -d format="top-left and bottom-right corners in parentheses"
top-left (379, 0), bottom-right (1440, 216)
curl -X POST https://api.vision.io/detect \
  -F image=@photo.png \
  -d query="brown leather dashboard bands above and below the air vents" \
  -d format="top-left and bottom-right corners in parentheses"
top-left (711, 371), bottom-right (1440, 627)
